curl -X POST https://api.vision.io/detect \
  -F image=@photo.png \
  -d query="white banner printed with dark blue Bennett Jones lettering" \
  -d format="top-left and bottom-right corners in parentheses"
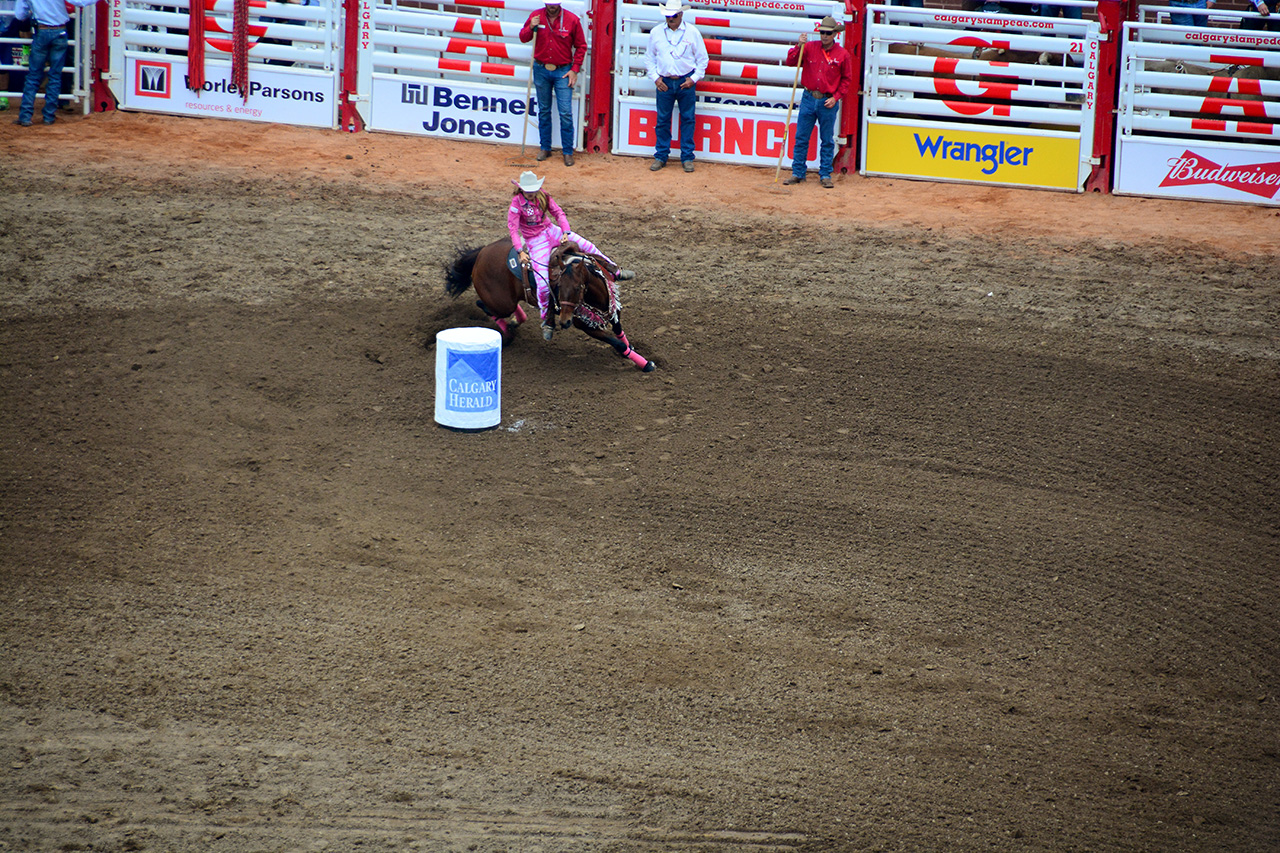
top-left (372, 74), bottom-right (581, 147)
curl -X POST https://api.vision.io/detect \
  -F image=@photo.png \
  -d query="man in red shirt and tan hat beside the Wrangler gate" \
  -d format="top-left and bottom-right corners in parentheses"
top-left (782, 15), bottom-right (854, 190)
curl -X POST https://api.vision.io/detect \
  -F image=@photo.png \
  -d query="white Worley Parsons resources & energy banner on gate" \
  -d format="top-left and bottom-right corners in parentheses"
top-left (122, 56), bottom-right (337, 127)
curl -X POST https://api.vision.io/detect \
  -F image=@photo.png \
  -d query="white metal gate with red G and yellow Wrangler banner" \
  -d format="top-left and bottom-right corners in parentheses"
top-left (859, 0), bottom-right (1102, 192)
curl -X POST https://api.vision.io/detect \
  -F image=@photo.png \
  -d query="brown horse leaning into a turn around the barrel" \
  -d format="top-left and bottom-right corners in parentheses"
top-left (444, 240), bottom-right (657, 373)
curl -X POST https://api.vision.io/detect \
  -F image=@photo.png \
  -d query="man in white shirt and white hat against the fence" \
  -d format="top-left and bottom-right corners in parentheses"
top-left (644, 0), bottom-right (707, 172)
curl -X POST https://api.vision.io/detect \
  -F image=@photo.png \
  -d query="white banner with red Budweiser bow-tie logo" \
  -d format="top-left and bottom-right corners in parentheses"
top-left (1116, 141), bottom-right (1280, 205)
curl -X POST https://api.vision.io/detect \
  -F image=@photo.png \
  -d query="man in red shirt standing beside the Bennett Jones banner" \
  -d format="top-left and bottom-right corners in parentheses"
top-left (520, 0), bottom-right (586, 165)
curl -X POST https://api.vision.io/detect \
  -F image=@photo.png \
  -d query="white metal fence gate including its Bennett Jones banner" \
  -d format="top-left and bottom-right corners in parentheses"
top-left (351, 0), bottom-right (591, 149)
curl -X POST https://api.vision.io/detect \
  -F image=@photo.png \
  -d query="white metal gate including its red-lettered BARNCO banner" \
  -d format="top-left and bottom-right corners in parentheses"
top-left (613, 0), bottom-right (856, 168)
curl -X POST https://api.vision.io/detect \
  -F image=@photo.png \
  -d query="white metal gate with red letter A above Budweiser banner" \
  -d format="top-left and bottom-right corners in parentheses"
top-left (1115, 8), bottom-right (1280, 206)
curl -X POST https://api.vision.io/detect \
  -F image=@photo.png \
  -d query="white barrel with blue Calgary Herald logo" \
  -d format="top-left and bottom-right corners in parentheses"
top-left (435, 327), bottom-right (502, 429)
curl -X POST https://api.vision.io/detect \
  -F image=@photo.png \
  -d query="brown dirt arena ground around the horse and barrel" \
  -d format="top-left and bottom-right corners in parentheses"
top-left (0, 114), bottom-right (1280, 853)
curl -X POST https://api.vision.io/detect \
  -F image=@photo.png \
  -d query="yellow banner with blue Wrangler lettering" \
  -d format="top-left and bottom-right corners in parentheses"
top-left (867, 123), bottom-right (1080, 192)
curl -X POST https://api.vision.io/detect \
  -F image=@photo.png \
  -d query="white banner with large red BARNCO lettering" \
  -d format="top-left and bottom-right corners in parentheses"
top-left (613, 99), bottom-right (819, 169)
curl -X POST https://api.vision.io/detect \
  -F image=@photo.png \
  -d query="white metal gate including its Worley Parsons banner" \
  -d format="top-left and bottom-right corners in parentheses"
top-left (105, 0), bottom-right (342, 127)
